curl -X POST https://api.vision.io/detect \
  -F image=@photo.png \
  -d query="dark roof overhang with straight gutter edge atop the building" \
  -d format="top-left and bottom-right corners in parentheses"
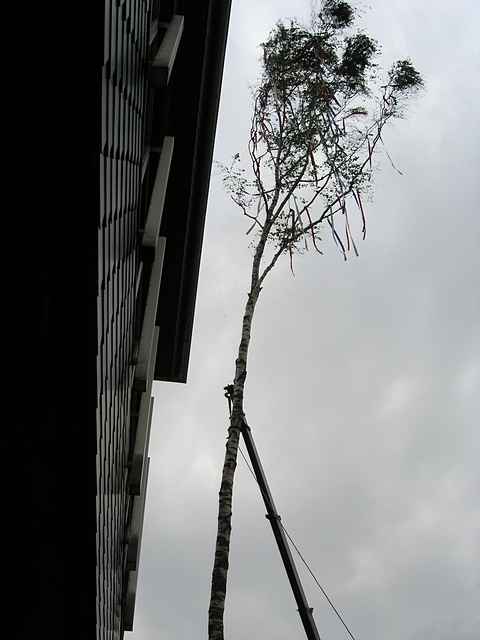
top-left (150, 0), bottom-right (231, 382)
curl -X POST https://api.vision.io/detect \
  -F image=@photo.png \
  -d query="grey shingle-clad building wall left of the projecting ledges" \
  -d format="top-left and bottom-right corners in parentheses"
top-left (97, 0), bottom-right (181, 640)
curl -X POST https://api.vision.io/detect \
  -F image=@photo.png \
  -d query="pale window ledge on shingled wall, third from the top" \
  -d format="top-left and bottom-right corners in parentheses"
top-left (134, 238), bottom-right (165, 391)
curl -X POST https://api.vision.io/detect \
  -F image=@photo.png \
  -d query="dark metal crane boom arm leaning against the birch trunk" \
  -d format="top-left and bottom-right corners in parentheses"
top-left (242, 417), bottom-right (320, 640)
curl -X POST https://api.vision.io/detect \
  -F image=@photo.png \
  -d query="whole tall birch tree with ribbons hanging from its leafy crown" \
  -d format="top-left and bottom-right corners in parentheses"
top-left (208, 0), bottom-right (423, 640)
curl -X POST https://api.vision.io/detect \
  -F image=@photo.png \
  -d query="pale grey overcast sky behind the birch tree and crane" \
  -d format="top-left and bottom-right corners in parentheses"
top-left (130, 0), bottom-right (480, 640)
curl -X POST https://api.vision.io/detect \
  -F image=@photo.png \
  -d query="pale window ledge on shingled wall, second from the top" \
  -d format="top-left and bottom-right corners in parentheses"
top-left (142, 136), bottom-right (175, 249)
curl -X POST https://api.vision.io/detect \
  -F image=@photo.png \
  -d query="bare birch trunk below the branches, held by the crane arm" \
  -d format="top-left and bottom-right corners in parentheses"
top-left (208, 288), bottom-right (260, 640)
